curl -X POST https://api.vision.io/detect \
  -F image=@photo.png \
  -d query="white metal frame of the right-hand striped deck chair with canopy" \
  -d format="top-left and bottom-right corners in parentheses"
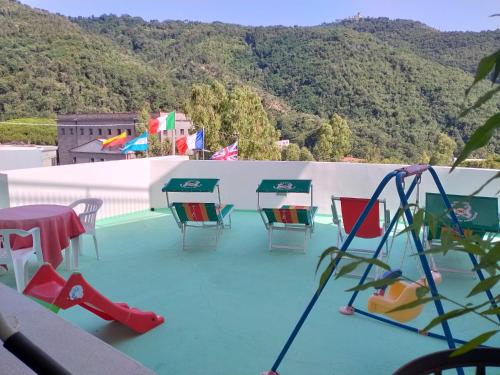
top-left (257, 179), bottom-right (317, 253)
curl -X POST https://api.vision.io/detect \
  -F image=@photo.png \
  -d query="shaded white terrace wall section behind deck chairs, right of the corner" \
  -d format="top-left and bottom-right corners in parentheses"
top-left (150, 158), bottom-right (500, 213)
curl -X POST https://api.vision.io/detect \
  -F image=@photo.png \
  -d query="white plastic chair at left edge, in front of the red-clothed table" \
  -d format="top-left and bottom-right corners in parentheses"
top-left (0, 228), bottom-right (43, 293)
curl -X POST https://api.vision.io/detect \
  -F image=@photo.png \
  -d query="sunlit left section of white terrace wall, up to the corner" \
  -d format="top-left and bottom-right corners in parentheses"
top-left (0, 159), bottom-right (150, 218)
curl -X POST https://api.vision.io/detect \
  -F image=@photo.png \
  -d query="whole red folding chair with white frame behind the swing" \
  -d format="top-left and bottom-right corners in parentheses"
top-left (331, 195), bottom-right (390, 276)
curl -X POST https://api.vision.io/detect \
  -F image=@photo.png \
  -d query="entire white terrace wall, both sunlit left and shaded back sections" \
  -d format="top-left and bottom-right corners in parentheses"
top-left (0, 157), bottom-right (500, 218)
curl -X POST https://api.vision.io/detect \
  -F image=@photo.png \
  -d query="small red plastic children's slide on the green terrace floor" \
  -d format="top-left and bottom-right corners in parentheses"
top-left (24, 263), bottom-right (165, 333)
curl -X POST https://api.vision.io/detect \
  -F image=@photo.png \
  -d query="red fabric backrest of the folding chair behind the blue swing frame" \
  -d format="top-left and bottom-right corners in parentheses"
top-left (332, 197), bottom-right (384, 238)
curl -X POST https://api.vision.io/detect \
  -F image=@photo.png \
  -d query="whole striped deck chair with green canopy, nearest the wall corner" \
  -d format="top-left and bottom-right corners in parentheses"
top-left (162, 178), bottom-right (234, 250)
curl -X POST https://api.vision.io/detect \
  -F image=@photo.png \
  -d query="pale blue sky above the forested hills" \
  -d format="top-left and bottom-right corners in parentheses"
top-left (21, 0), bottom-right (500, 31)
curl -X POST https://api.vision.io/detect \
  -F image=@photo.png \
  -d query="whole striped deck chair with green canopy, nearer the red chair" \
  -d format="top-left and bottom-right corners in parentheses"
top-left (257, 180), bottom-right (318, 252)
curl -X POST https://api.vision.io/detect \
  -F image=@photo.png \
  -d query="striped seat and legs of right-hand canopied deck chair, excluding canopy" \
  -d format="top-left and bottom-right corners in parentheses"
top-left (261, 205), bottom-right (318, 252)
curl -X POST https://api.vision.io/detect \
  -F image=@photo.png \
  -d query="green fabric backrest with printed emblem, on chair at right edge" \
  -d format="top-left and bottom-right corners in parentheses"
top-left (425, 193), bottom-right (500, 238)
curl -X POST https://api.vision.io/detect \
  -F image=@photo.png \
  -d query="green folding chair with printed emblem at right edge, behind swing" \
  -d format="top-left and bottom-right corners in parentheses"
top-left (424, 193), bottom-right (500, 273)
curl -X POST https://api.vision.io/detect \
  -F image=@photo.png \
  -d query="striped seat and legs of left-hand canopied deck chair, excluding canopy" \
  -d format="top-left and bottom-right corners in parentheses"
top-left (170, 202), bottom-right (234, 250)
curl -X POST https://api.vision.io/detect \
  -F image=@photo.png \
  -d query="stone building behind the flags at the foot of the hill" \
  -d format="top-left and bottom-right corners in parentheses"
top-left (57, 112), bottom-right (192, 164)
